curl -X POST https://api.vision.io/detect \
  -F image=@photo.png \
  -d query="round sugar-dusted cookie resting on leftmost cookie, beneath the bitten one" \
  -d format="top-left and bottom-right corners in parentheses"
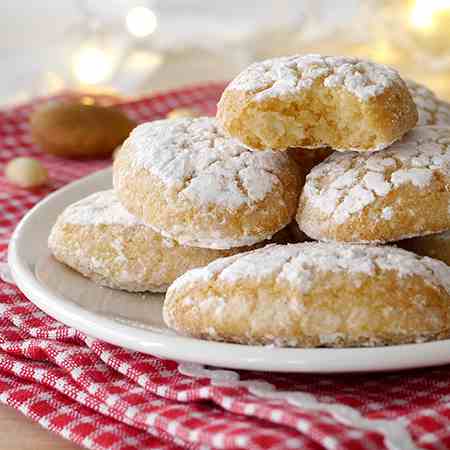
top-left (114, 117), bottom-right (303, 249)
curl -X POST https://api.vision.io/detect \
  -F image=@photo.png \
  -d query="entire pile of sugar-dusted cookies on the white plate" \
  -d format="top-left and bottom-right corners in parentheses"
top-left (49, 55), bottom-right (450, 347)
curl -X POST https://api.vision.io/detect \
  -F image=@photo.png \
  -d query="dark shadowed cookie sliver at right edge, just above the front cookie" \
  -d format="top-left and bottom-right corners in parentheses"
top-left (397, 230), bottom-right (450, 266)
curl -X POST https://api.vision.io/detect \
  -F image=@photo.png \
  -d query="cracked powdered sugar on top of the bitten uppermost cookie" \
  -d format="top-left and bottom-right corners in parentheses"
top-left (228, 54), bottom-right (403, 102)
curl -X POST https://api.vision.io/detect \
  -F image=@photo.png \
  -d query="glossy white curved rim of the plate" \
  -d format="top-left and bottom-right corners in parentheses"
top-left (8, 166), bottom-right (450, 374)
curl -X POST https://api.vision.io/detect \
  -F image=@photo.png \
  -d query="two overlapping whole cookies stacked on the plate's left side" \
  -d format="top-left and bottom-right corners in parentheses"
top-left (49, 117), bottom-right (304, 292)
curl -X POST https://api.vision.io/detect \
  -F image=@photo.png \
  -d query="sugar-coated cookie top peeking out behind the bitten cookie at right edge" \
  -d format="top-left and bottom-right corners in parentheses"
top-left (406, 80), bottom-right (450, 125)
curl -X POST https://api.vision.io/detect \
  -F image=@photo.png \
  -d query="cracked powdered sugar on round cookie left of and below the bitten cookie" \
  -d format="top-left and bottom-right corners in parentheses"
top-left (125, 117), bottom-right (288, 209)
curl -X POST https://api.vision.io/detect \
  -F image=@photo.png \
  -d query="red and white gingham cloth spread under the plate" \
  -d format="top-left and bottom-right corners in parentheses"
top-left (0, 84), bottom-right (450, 450)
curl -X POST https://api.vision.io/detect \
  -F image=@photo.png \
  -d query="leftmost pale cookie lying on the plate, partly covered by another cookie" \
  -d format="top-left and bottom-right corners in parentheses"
top-left (49, 190), bottom-right (253, 292)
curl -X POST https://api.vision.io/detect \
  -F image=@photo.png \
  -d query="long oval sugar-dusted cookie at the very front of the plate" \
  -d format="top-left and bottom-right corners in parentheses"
top-left (163, 243), bottom-right (450, 347)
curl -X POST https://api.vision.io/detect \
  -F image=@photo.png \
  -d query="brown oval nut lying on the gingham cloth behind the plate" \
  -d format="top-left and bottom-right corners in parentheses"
top-left (31, 102), bottom-right (136, 158)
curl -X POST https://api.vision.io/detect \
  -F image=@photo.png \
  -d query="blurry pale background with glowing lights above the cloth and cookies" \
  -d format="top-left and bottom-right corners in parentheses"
top-left (0, 0), bottom-right (450, 106)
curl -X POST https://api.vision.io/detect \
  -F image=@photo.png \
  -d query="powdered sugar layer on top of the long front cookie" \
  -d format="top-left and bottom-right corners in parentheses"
top-left (167, 242), bottom-right (450, 296)
